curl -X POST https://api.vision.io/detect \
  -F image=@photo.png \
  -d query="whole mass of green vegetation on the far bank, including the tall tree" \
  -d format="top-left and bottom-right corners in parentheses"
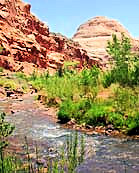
top-left (13, 35), bottom-right (139, 135)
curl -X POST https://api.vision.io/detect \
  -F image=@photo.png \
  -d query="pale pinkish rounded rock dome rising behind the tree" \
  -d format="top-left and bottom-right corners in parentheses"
top-left (73, 17), bottom-right (139, 66)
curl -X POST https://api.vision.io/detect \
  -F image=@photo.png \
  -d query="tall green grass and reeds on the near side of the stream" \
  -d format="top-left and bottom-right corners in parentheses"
top-left (0, 113), bottom-right (85, 173)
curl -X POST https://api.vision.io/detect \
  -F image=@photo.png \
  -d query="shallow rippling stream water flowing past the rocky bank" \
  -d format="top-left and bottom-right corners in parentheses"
top-left (0, 96), bottom-right (139, 173)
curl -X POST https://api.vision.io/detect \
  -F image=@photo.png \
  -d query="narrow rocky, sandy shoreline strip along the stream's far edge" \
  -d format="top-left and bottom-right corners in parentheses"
top-left (0, 88), bottom-right (139, 139)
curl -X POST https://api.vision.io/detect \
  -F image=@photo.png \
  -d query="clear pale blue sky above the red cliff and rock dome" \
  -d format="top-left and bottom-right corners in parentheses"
top-left (24, 0), bottom-right (139, 37)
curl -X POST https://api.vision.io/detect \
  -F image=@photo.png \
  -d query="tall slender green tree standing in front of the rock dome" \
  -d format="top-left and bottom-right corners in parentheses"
top-left (107, 34), bottom-right (133, 85)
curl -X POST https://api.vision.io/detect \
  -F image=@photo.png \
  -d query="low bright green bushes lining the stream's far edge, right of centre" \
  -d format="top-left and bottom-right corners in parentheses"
top-left (58, 86), bottom-right (139, 133)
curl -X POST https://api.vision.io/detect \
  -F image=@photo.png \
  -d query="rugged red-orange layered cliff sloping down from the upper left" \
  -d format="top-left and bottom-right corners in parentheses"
top-left (0, 0), bottom-right (95, 72)
